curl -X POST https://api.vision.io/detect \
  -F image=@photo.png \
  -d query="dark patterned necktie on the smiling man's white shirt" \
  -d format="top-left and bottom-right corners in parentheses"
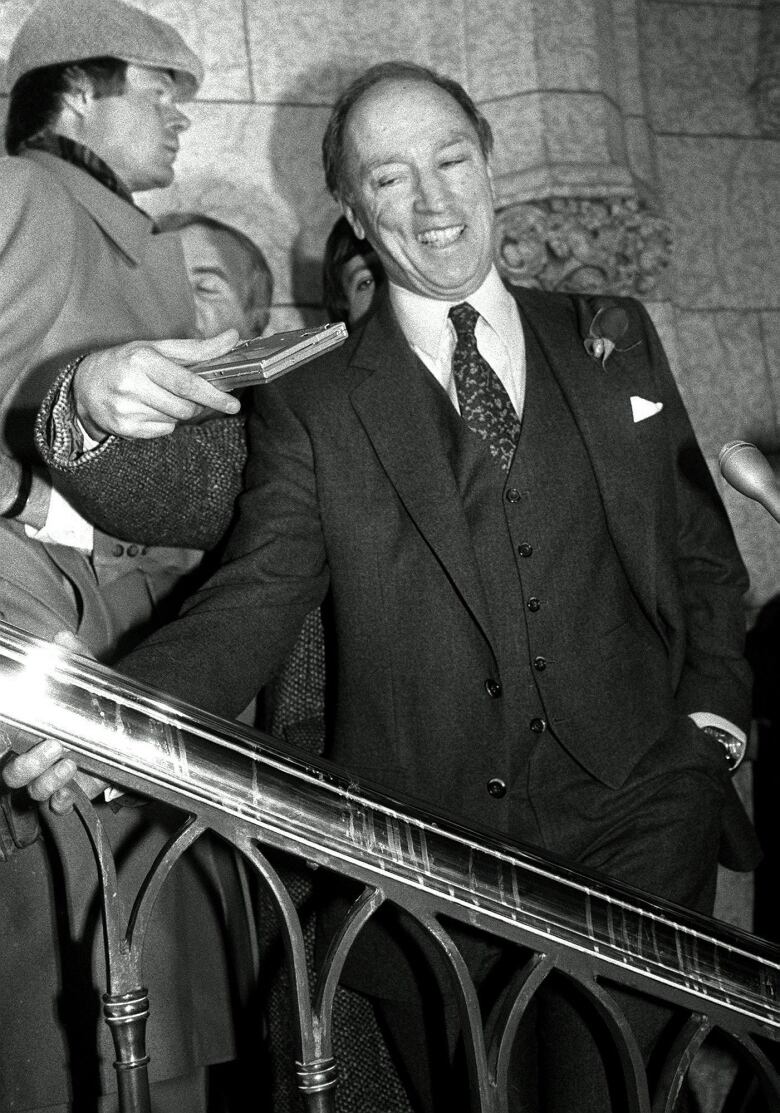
top-left (450, 302), bottom-right (520, 472)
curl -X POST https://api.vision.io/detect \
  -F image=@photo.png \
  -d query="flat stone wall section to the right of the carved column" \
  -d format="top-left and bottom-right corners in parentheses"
top-left (641, 0), bottom-right (780, 612)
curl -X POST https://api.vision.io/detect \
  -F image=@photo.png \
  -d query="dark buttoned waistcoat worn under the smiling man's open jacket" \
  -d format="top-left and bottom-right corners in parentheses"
top-left (416, 309), bottom-right (672, 829)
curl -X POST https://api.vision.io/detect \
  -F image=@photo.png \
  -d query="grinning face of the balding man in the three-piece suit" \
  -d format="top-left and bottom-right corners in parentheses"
top-left (338, 73), bottom-right (493, 303)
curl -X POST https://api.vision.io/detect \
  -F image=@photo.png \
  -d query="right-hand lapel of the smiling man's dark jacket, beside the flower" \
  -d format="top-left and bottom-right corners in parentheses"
top-left (512, 282), bottom-right (656, 608)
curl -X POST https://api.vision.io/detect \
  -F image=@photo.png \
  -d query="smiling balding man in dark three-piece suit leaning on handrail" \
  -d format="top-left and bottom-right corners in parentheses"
top-left (7, 62), bottom-right (756, 1113)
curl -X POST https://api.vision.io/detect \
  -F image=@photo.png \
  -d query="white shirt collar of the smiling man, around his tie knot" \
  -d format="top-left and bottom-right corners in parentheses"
top-left (388, 266), bottom-right (516, 359)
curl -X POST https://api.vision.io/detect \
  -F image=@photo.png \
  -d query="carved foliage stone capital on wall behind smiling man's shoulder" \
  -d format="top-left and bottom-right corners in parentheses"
top-left (495, 197), bottom-right (672, 297)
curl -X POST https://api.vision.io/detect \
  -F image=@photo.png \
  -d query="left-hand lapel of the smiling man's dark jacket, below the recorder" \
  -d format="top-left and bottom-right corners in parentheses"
top-left (352, 298), bottom-right (492, 644)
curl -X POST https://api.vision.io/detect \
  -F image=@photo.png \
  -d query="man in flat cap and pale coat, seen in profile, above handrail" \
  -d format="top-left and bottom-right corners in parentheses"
top-left (0, 0), bottom-right (234, 645)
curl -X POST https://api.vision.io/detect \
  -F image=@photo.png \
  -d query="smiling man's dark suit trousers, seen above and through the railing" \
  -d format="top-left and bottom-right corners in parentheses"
top-left (362, 717), bottom-right (730, 1113)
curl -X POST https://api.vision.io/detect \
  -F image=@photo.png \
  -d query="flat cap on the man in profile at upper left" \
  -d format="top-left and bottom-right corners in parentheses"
top-left (7, 0), bottom-right (204, 99)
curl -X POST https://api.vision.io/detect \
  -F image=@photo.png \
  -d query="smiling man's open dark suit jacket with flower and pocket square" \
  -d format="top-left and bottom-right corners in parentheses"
top-left (121, 282), bottom-right (750, 826)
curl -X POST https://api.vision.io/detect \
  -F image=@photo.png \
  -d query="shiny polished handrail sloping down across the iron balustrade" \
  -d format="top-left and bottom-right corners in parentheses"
top-left (0, 623), bottom-right (780, 1109)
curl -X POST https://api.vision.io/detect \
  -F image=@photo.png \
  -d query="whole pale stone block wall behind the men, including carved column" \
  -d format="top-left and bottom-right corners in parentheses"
top-left (0, 0), bottom-right (780, 613)
